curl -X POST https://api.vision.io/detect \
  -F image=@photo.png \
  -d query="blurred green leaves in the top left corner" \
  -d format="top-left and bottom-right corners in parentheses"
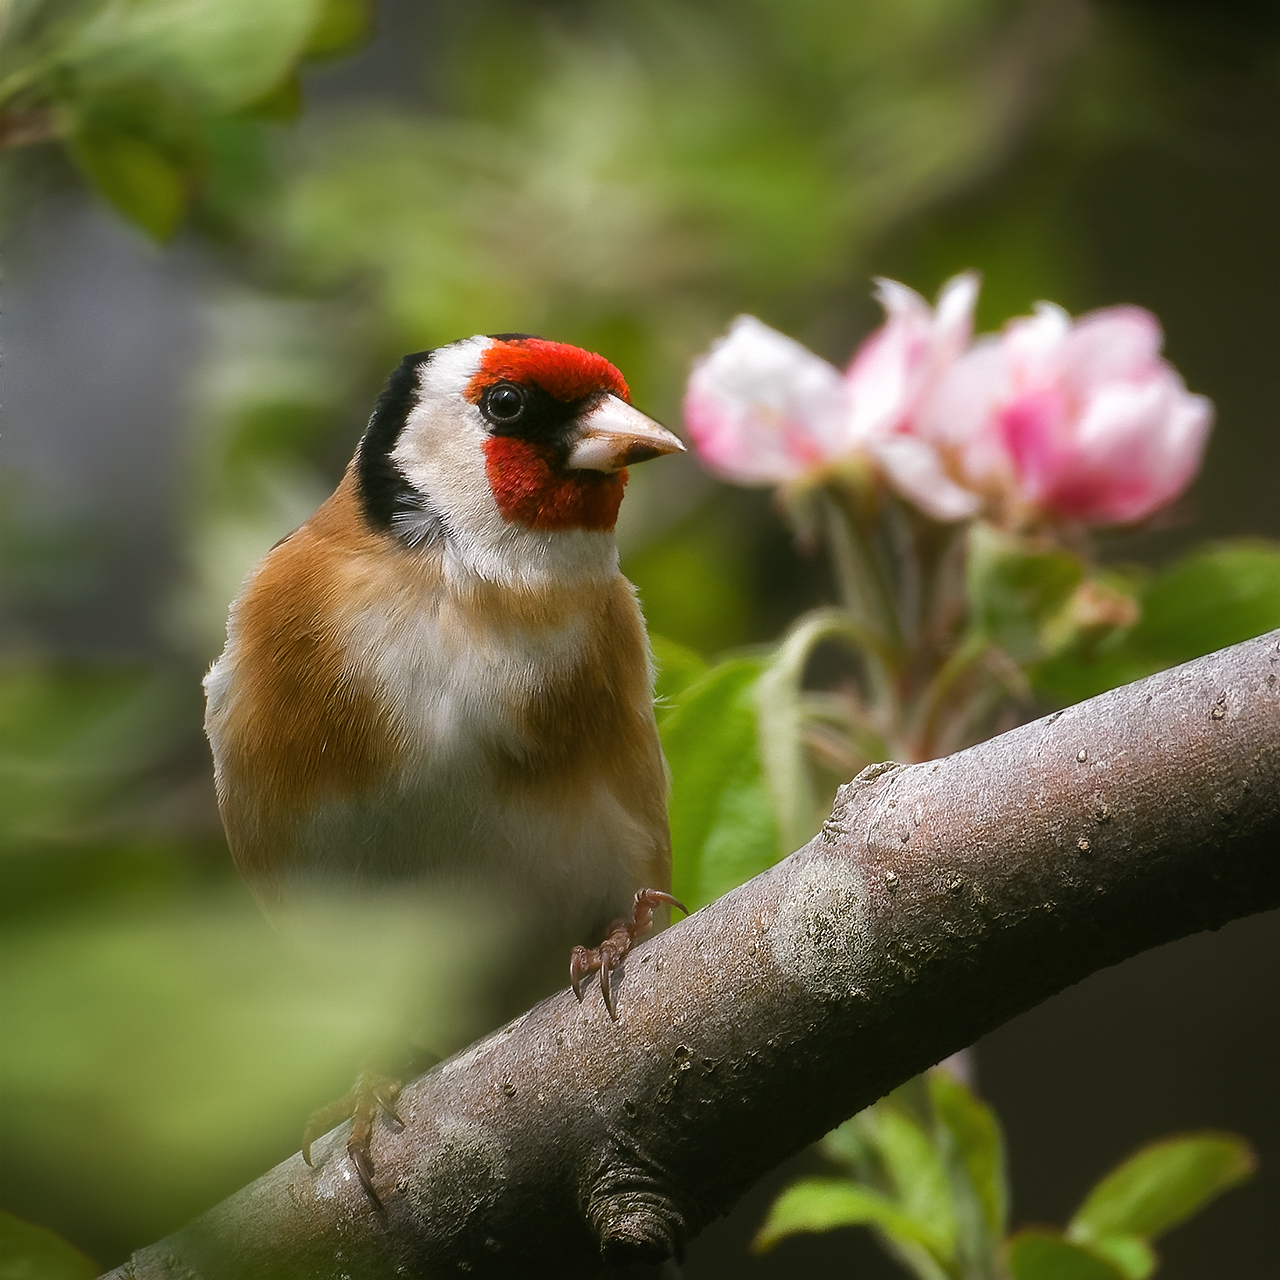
top-left (0, 0), bottom-right (371, 239)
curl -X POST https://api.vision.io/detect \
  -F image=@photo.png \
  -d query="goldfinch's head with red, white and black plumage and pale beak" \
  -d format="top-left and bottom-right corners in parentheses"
top-left (355, 334), bottom-right (684, 579)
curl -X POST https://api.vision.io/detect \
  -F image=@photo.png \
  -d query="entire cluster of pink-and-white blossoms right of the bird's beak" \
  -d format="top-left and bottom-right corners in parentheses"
top-left (685, 282), bottom-right (1212, 524)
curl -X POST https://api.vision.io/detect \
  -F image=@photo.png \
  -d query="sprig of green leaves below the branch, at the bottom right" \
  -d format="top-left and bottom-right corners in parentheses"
top-left (755, 1068), bottom-right (1257, 1280)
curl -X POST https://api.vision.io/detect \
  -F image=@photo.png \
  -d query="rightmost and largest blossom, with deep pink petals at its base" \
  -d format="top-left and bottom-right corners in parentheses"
top-left (918, 303), bottom-right (1212, 525)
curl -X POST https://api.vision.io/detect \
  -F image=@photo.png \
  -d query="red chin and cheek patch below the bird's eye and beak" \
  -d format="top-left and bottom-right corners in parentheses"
top-left (484, 432), bottom-right (627, 532)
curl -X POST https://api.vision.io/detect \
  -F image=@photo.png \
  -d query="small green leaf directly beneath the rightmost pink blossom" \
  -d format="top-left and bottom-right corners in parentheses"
top-left (965, 522), bottom-right (1084, 662)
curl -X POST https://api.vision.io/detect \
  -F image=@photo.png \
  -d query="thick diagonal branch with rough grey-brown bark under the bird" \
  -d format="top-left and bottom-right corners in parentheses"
top-left (102, 631), bottom-right (1280, 1280)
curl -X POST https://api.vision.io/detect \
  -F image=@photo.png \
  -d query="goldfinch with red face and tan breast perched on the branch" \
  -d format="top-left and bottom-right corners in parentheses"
top-left (205, 333), bottom-right (685, 1203)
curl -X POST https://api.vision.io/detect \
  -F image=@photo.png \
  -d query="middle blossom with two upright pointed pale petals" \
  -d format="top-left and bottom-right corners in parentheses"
top-left (845, 273), bottom-right (983, 520)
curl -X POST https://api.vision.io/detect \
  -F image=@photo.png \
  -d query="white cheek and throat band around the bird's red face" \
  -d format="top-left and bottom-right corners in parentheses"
top-left (392, 337), bottom-right (618, 586)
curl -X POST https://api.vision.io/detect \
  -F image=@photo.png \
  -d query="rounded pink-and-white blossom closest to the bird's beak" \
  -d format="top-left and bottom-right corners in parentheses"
top-left (685, 316), bottom-right (849, 485)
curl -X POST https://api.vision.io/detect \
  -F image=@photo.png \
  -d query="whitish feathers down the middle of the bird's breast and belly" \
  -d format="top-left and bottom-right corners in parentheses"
top-left (288, 585), bottom-right (654, 919)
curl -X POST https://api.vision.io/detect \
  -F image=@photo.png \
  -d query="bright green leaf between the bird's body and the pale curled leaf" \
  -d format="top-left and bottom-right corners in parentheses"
top-left (660, 658), bottom-right (782, 909)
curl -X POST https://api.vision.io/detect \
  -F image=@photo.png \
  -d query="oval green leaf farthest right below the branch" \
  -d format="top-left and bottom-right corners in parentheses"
top-left (1068, 1133), bottom-right (1257, 1240)
